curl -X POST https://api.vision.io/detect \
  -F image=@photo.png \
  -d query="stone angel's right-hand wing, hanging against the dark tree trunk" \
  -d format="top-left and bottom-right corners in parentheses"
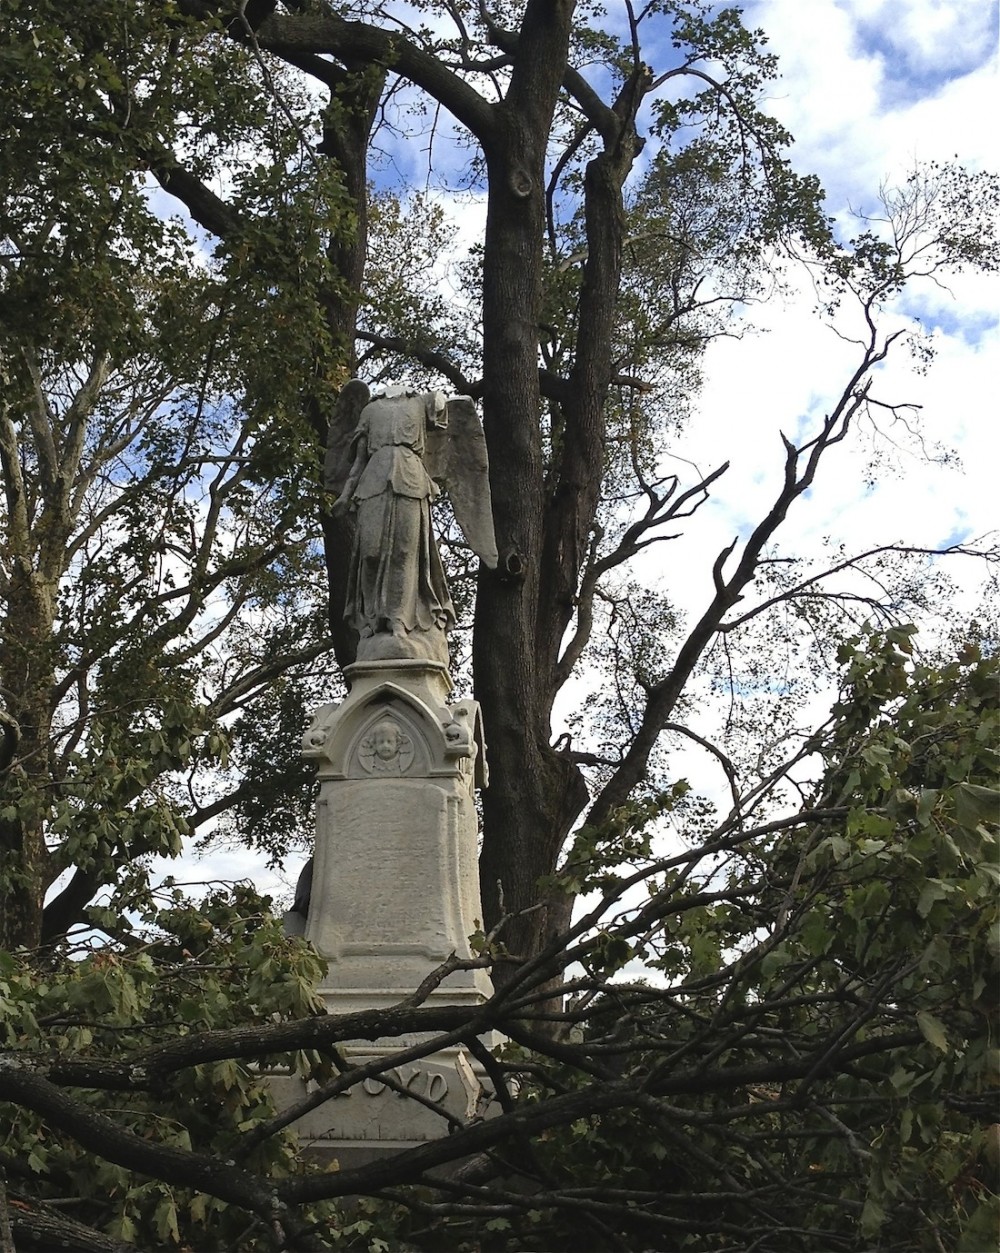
top-left (424, 396), bottom-right (497, 570)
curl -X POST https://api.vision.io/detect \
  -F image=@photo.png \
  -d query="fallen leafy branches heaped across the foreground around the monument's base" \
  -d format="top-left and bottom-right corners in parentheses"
top-left (0, 628), bottom-right (1000, 1253)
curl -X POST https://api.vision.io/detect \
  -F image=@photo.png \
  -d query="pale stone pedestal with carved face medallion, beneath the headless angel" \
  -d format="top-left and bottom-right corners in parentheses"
top-left (285, 659), bottom-right (491, 1155)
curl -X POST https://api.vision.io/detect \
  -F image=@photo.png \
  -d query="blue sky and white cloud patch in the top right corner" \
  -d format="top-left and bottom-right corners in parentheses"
top-left (746, 0), bottom-right (1000, 196)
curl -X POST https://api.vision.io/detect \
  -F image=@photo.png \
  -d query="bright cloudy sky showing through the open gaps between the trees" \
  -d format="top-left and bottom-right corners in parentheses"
top-left (170, 0), bottom-right (1000, 893)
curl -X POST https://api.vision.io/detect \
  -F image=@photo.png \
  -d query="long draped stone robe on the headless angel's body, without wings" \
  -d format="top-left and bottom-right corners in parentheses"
top-left (345, 392), bottom-right (455, 639)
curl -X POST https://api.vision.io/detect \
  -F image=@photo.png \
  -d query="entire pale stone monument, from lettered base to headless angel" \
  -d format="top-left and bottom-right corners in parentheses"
top-left (278, 381), bottom-right (496, 1158)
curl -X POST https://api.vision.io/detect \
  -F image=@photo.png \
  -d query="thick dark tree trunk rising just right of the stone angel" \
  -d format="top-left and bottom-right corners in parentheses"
top-left (474, 4), bottom-right (586, 986)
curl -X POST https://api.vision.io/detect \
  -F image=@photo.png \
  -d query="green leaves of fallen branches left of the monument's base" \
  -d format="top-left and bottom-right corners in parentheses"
top-left (0, 886), bottom-right (335, 1249)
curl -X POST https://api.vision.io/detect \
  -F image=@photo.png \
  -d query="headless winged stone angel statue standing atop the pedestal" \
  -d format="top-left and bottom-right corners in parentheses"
top-left (325, 378), bottom-right (496, 664)
